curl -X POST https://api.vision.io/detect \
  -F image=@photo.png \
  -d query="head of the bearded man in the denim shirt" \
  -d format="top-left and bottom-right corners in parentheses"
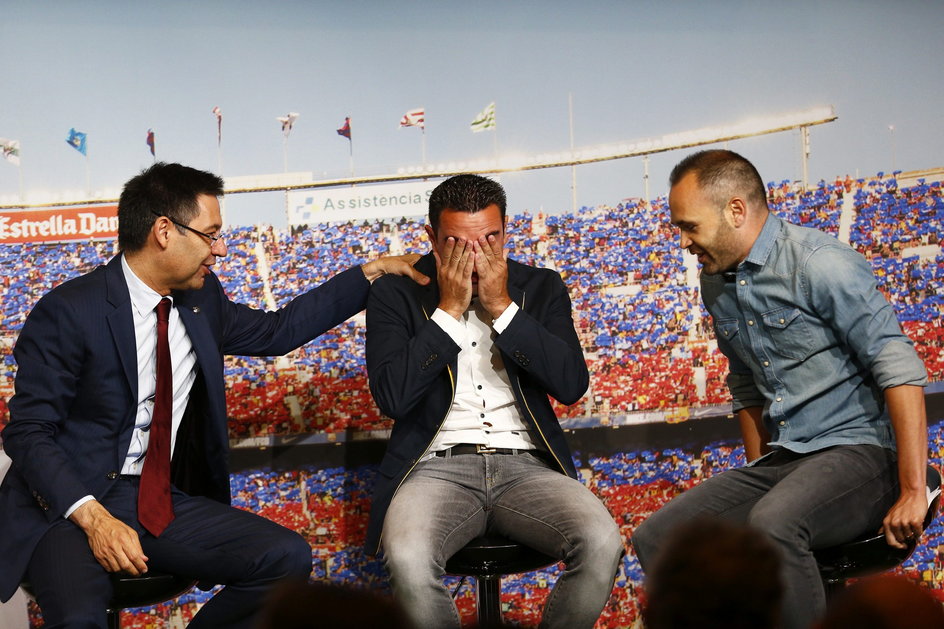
top-left (669, 150), bottom-right (768, 275)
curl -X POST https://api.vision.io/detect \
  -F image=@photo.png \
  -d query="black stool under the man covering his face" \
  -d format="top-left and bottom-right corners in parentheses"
top-left (446, 535), bottom-right (558, 628)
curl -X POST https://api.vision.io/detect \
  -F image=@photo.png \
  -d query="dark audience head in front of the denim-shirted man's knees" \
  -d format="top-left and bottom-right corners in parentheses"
top-left (642, 518), bottom-right (783, 629)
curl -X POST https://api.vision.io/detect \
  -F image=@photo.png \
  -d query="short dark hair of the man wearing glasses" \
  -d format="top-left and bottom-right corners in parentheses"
top-left (118, 162), bottom-right (223, 251)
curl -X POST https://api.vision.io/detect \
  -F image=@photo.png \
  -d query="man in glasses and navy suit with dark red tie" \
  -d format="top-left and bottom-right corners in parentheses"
top-left (0, 163), bottom-right (427, 628)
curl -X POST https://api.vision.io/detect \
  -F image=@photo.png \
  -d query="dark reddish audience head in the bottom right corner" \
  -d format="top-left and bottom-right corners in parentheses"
top-left (815, 575), bottom-right (944, 629)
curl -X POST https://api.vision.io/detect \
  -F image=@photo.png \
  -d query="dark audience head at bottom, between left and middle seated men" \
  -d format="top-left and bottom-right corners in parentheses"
top-left (256, 580), bottom-right (410, 629)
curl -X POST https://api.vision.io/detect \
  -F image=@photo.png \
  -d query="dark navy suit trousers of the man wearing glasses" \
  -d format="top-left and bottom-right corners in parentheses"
top-left (27, 480), bottom-right (311, 629)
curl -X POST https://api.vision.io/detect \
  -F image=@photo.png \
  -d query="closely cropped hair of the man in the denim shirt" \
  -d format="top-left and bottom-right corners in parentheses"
top-left (669, 149), bottom-right (767, 209)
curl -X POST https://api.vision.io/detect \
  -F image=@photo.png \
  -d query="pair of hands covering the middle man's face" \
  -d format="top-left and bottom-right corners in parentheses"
top-left (433, 234), bottom-right (511, 320)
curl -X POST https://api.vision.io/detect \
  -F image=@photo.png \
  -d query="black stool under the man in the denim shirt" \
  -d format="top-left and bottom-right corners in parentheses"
top-left (813, 465), bottom-right (941, 597)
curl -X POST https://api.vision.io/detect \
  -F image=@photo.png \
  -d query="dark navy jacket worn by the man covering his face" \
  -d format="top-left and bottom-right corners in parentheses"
top-left (366, 254), bottom-right (590, 552)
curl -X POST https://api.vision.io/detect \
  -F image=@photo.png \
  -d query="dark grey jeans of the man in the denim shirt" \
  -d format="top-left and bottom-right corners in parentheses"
top-left (632, 445), bottom-right (898, 629)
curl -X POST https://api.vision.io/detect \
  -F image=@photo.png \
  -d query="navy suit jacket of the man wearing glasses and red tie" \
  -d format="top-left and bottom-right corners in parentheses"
top-left (0, 256), bottom-right (370, 601)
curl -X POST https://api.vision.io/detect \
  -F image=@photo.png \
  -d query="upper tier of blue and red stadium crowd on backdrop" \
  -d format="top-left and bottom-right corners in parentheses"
top-left (0, 173), bottom-right (944, 438)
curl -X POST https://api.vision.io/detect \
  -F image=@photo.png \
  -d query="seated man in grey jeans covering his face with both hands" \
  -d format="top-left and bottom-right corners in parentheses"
top-left (367, 175), bottom-right (623, 629)
